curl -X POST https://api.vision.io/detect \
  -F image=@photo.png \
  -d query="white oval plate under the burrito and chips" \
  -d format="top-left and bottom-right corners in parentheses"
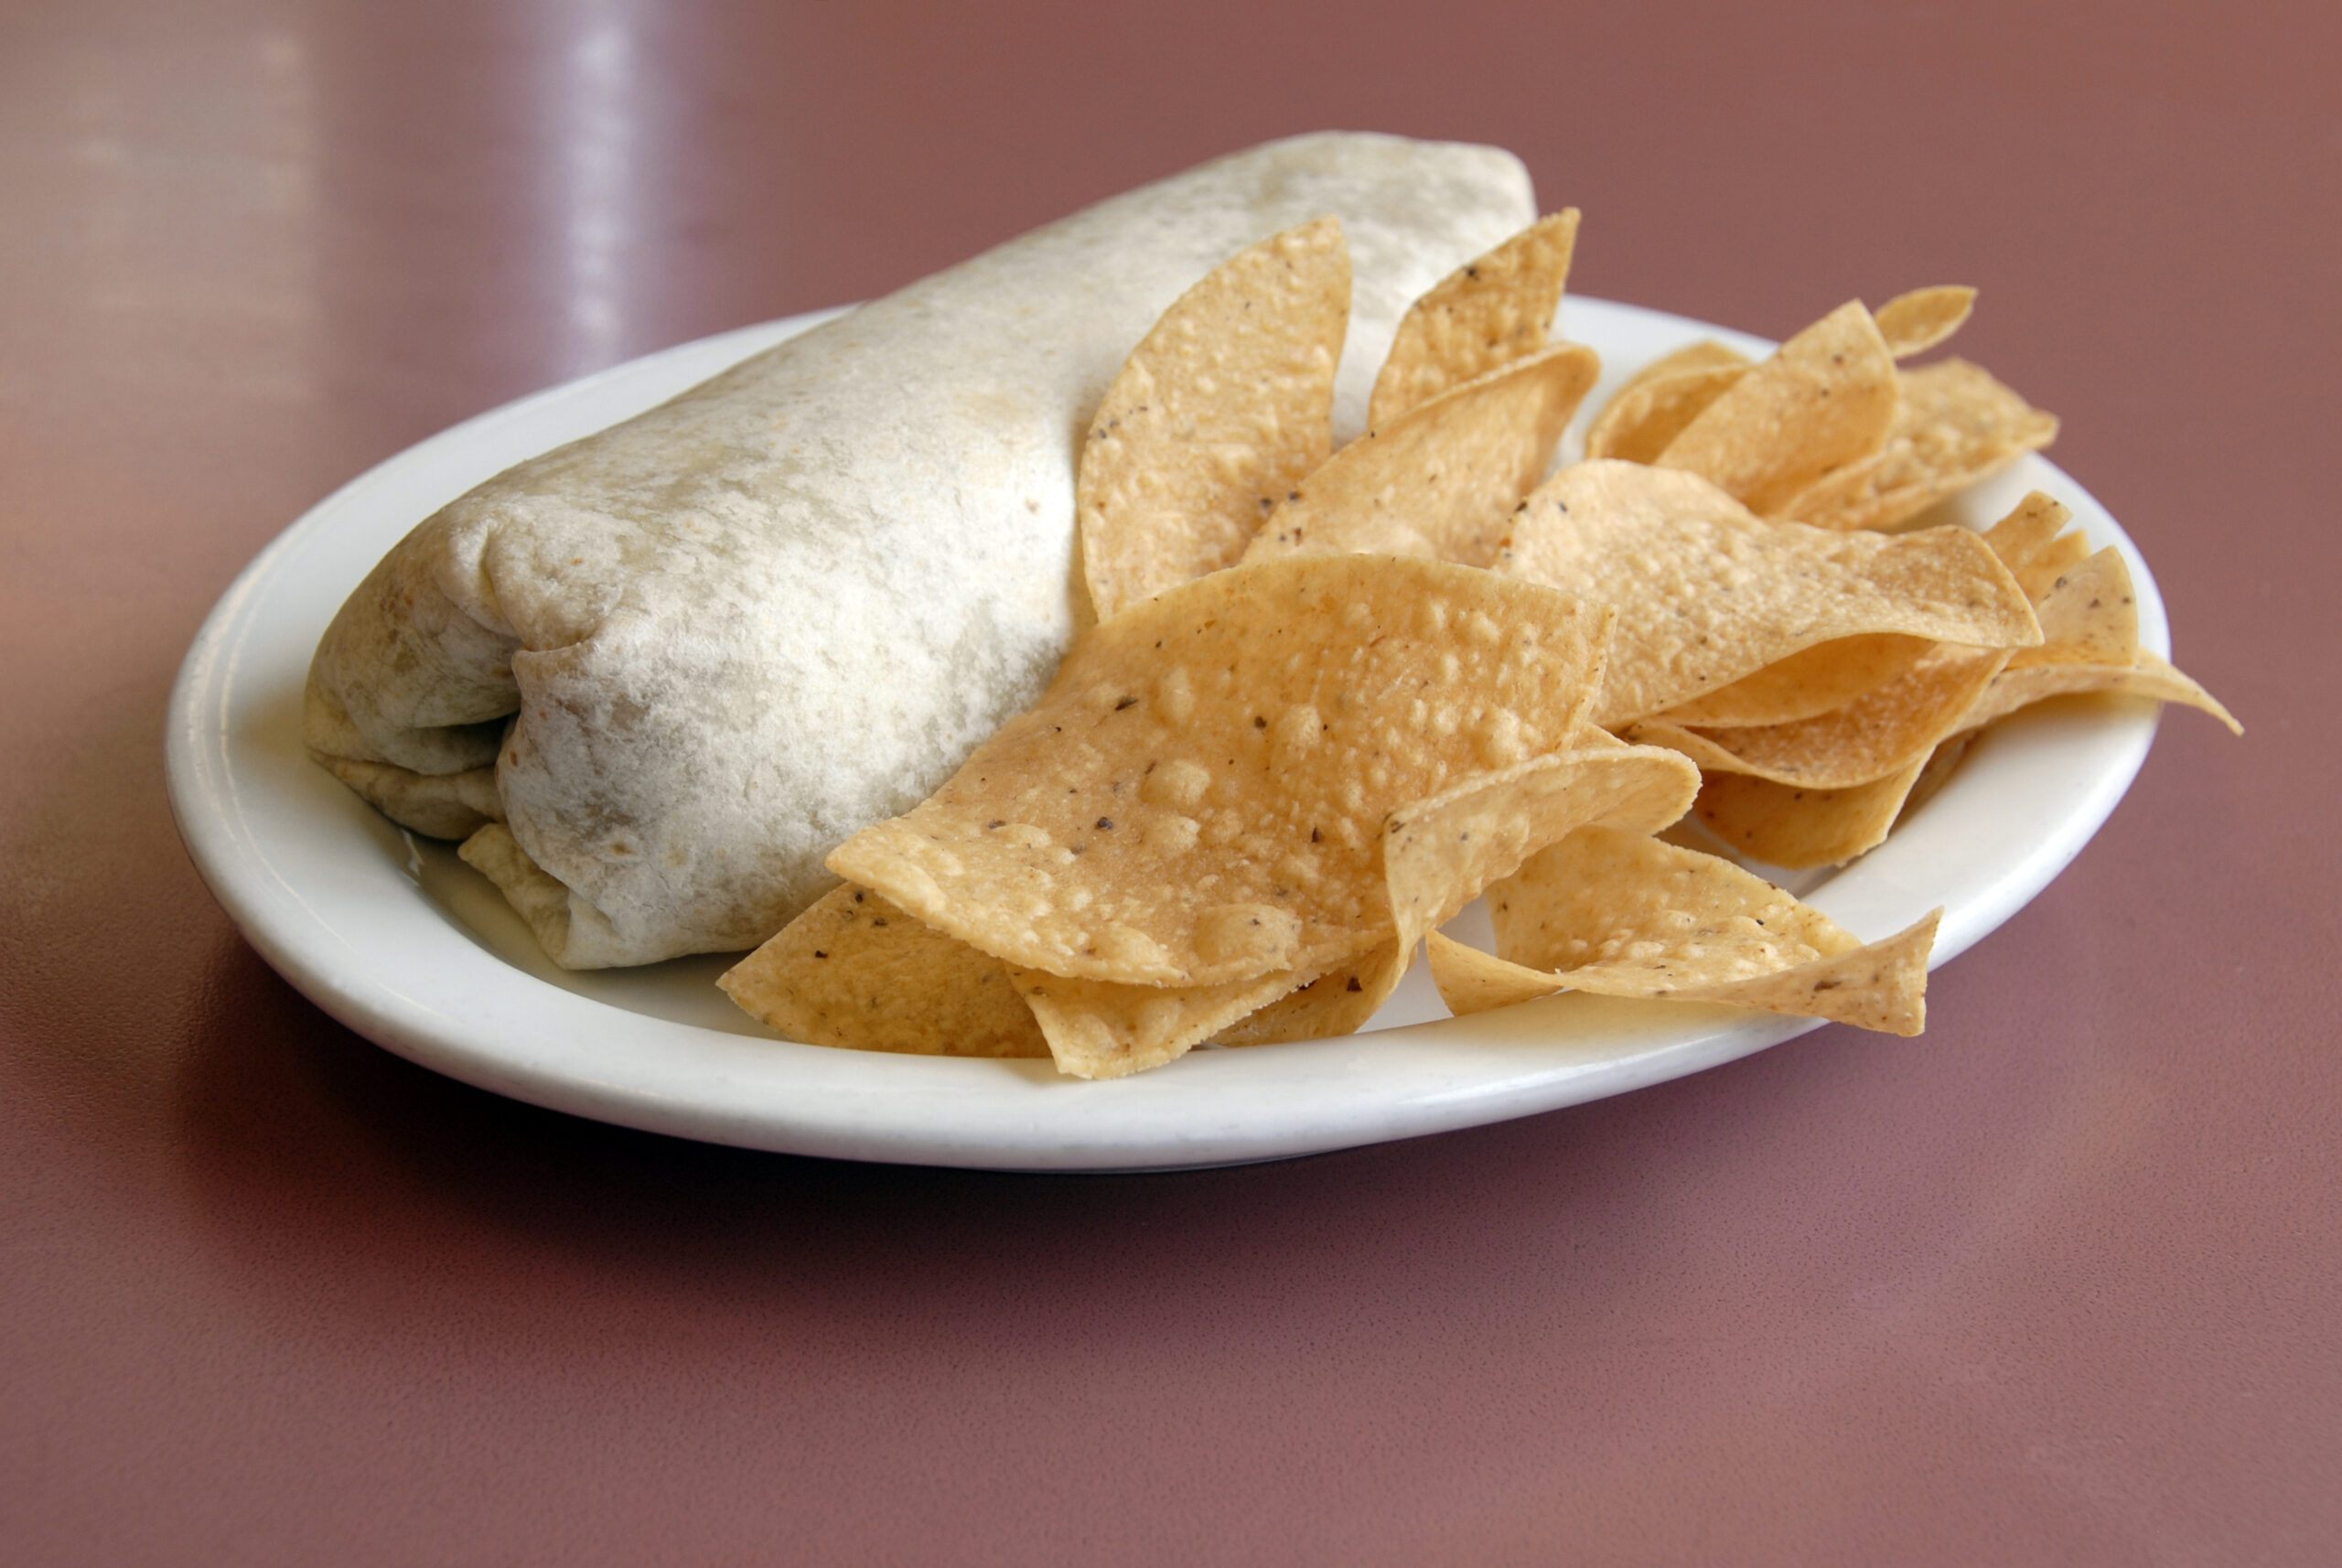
top-left (168, 297), bottom-right (2169, 1170)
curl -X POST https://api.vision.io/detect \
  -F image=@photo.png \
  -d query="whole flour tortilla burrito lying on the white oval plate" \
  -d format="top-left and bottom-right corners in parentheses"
top-left (305, 134), bottom-right (1536, 969)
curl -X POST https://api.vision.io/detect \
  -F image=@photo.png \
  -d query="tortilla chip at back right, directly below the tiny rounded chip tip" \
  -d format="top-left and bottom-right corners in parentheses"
top-left (1759, 360), bottom-right (2057, 529)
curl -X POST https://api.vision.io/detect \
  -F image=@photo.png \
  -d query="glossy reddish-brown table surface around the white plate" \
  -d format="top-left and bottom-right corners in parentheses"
top-left (0, 0), bottom-right (2342, 1563)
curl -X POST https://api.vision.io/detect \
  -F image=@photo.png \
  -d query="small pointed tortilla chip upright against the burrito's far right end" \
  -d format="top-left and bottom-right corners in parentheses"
top-left (1365, 206), bottom-right (1578, 431)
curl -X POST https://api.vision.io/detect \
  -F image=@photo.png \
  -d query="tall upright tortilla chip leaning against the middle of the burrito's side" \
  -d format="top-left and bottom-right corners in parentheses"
top-left (1075, 218), bottom-right (1349, 620)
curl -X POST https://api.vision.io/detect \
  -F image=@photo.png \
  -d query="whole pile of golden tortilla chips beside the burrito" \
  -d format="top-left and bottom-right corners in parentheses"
top-left (721, 210), bottom-right (2234, 1079)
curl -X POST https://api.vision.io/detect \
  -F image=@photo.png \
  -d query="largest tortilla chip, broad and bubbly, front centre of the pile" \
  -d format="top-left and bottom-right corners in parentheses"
top-left (829, 554), bottom-right (1611, 985)
